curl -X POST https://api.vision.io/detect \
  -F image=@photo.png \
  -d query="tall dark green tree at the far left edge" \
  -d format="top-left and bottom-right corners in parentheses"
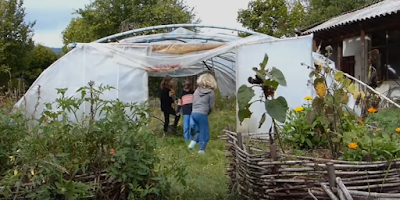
top-left (0, 0), bottom-right (35, 84)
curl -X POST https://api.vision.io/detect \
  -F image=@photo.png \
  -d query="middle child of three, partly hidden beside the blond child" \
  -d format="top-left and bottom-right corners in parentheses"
top-left (177, 80), bottom-right (193, 141)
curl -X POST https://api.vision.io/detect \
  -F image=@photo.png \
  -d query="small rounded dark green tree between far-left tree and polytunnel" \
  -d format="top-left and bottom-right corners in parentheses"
top-left (24, 44), bottom-right (58, 85)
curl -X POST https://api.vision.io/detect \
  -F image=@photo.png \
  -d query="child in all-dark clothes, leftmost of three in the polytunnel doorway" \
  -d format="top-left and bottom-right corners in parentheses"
top-left (160, 76), bottom-right (180, 132)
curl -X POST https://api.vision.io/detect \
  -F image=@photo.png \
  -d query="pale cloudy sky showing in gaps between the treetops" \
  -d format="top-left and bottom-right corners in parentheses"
top-left (25, 0), bottom-right (250, 47)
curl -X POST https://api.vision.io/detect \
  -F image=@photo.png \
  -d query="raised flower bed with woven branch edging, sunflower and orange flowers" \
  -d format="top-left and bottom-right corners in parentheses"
top-left (231, 51), bottom-right (400, 200)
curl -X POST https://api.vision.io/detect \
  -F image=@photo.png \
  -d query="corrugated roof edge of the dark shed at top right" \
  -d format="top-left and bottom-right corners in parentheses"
top-left (303, 0), bottom-right (400, 34)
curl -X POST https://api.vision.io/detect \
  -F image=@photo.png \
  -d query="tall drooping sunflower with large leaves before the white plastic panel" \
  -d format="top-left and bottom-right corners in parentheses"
top-left (237, 55), bottom-right (289, 127)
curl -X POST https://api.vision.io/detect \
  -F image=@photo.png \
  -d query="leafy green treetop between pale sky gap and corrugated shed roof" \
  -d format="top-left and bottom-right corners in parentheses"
top-left (237, 0), bottom-right (305, 37)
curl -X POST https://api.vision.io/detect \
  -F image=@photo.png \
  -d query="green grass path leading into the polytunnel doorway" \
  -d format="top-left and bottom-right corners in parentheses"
top-left (150, 97), bottom-right (236, 200)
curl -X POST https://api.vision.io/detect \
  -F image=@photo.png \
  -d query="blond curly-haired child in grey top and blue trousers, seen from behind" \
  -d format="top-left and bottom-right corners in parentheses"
top-left (189, 73), bottom-right (217, 154)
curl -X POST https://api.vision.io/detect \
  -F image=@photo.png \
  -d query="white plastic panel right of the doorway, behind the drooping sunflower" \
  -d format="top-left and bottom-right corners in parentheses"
top-left (236, 35), bottom-right (313, 133)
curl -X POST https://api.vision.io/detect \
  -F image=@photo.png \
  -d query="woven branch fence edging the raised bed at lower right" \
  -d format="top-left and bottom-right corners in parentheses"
top-left (221, 130), bottom-right (400, 200)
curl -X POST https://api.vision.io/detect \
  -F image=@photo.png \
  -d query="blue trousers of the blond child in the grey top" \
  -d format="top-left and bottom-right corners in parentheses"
top-left (192, 113), bottom-right (210, 150)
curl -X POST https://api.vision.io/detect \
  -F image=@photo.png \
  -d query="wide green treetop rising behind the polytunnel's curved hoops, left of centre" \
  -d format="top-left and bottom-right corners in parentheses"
top-left (63, 0), bottom-right (199, 48)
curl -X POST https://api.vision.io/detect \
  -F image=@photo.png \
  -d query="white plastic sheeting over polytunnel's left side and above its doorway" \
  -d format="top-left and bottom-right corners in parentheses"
top-left (16, 35), bottom-right (278, 118)
